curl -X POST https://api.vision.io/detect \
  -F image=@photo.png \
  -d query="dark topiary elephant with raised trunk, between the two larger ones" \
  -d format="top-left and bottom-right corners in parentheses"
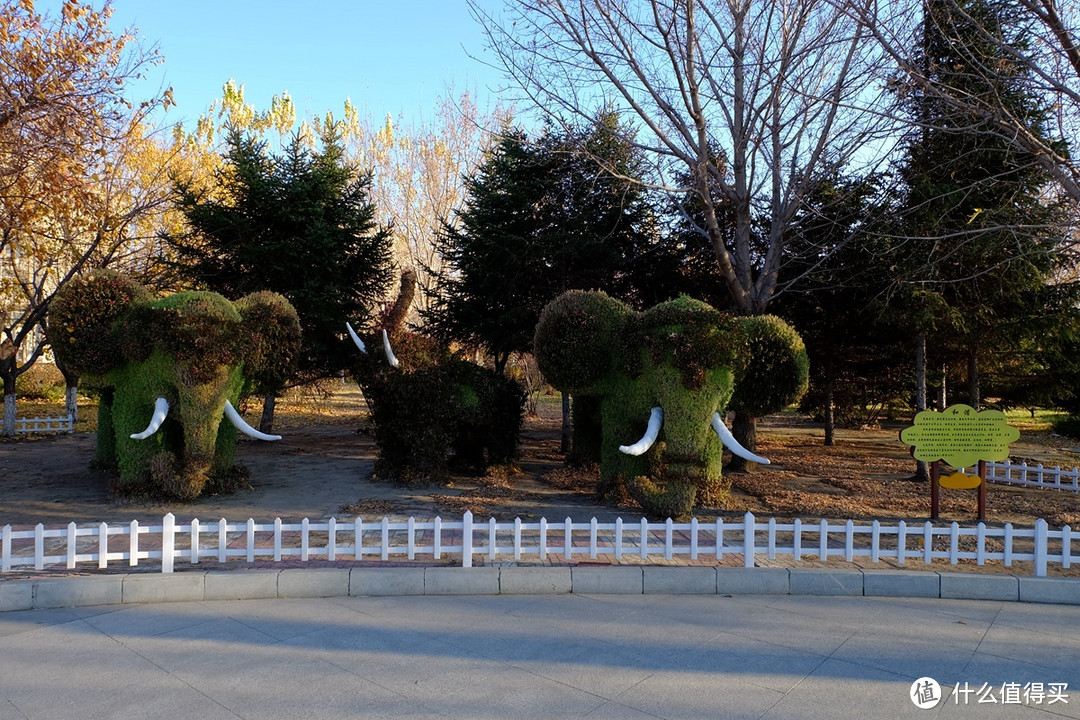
top-left (346, 271), bottom-right (525, 485)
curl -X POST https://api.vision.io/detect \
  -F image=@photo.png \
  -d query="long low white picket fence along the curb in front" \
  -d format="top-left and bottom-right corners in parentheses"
top-left (0, 512), bottom-right (1080, 576)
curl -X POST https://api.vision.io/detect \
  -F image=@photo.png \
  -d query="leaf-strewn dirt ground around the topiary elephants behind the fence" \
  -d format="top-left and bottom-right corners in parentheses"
top-left (0, 396), bottom-right (1080, 527)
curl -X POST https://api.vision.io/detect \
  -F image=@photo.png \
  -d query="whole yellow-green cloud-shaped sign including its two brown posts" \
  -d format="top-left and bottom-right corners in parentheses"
top-left (900, 405), bottom-right (1020, 520)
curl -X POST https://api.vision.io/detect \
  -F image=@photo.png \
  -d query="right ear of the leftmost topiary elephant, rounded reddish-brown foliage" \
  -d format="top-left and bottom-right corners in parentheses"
top-left (235, 290), bottom-right (300, 394)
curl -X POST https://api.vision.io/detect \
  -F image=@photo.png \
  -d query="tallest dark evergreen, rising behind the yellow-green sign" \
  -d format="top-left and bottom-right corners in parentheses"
top-left (893, 0), bottom-right (1061, 407)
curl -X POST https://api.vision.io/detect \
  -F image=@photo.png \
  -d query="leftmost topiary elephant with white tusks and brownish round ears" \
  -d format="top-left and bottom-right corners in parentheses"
top-left (48, 271), bottom-right (300, 500)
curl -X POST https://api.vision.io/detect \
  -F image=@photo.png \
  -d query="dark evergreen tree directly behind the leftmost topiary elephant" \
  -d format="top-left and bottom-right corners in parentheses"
top-left (170, 126), bottom-right (391, 390)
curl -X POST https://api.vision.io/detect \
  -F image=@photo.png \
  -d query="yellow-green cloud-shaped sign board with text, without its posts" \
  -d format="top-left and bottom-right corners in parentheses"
top-left (900, 405), bottom-right (1020, 467)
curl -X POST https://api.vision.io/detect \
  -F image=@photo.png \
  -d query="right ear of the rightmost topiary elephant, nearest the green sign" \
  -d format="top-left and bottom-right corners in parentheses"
top-left (728, 315), bottom-right (810, 418)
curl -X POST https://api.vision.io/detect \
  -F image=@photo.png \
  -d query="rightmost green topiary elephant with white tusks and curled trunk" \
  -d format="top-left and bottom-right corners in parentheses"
top-left (534, 290), bottom-right (808, 517)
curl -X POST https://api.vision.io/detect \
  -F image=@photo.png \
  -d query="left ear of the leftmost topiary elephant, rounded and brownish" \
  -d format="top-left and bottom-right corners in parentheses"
top-left (46, 270), bottom-right (151, 376)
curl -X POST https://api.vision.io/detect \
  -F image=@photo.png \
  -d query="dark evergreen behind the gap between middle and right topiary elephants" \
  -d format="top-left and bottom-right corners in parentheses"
top-left (426, 116), bottom-right (656, 369)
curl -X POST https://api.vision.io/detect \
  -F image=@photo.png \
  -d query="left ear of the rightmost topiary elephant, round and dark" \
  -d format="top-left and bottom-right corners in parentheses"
top-left (532, 290), bottom-right (633, 395)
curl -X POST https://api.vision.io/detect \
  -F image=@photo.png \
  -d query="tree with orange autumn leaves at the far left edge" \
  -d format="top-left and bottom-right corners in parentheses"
top-left (0, 0), bottom-right (172, 434)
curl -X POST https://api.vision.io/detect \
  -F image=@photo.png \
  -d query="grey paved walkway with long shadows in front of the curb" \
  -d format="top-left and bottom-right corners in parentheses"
top-left (0, 595), bottom-right (1080, 720)
